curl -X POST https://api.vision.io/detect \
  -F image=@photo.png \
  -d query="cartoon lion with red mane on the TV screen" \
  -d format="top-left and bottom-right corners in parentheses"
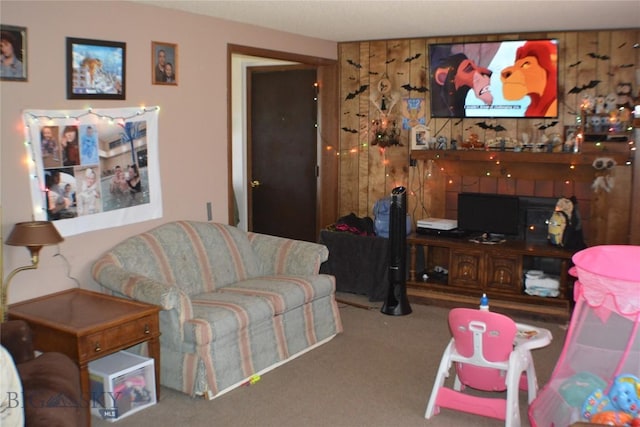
top-left (500, 40), bottom-right (558, 117)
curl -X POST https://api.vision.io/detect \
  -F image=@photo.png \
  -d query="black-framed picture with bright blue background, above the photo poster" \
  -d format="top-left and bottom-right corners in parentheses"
top-left (67, 37), bottom-right (126, 99)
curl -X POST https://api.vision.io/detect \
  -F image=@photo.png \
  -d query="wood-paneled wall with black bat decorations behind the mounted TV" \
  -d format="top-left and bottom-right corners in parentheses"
top-left (338, 29), bottom-right (640, 245)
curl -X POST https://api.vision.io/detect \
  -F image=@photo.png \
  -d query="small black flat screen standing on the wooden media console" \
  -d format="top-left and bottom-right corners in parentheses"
top-left (458, 192), bottom-right (521, 237)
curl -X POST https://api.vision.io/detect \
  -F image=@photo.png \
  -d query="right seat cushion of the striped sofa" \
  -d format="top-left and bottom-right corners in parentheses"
top-left (220, 275), bottom-right (335, 314)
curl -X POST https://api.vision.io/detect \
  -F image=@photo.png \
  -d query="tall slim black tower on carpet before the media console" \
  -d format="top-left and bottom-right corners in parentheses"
top-left (380, 187), bottom-right (411, 316)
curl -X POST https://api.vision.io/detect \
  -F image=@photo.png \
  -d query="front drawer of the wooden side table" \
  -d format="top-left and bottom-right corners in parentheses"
top-left (78, 315), bottom-right (160, 359)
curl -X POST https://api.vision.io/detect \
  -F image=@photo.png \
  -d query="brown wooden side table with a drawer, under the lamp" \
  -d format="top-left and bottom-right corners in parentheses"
top-left (9, 289), bottom-right (160, 419)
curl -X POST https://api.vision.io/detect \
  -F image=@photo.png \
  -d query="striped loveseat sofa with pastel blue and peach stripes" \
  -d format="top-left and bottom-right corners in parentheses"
top-left (92, 221), bottom-right (342, 398)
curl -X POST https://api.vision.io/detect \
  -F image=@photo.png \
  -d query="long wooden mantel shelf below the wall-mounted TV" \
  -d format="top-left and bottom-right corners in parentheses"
top-left (411, 150), bottom-right (630, 166)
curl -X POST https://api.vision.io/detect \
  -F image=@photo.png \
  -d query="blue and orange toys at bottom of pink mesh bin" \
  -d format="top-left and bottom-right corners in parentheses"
top-left (582, 374), bottom-right (640, 426)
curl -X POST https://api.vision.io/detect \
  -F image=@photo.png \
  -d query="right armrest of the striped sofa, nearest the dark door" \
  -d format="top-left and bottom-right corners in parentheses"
top-left (249, 233), bottom-right (329, 276)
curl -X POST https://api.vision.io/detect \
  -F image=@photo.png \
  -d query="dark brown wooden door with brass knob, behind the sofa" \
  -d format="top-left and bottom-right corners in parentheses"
top-left (247, 66), bottom-right (318, 242)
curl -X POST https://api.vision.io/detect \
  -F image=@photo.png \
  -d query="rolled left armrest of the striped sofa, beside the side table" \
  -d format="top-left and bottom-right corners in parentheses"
top-left (92, 262), bottom-right (193, 322)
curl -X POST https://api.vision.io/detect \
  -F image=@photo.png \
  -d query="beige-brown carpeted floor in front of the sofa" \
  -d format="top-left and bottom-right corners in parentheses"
top-left (92, 294), bottom-right (566, 427)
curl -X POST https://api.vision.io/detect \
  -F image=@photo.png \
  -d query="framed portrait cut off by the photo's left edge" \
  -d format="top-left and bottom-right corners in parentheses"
top-left (0, 25), bottom-right (27, 82)
